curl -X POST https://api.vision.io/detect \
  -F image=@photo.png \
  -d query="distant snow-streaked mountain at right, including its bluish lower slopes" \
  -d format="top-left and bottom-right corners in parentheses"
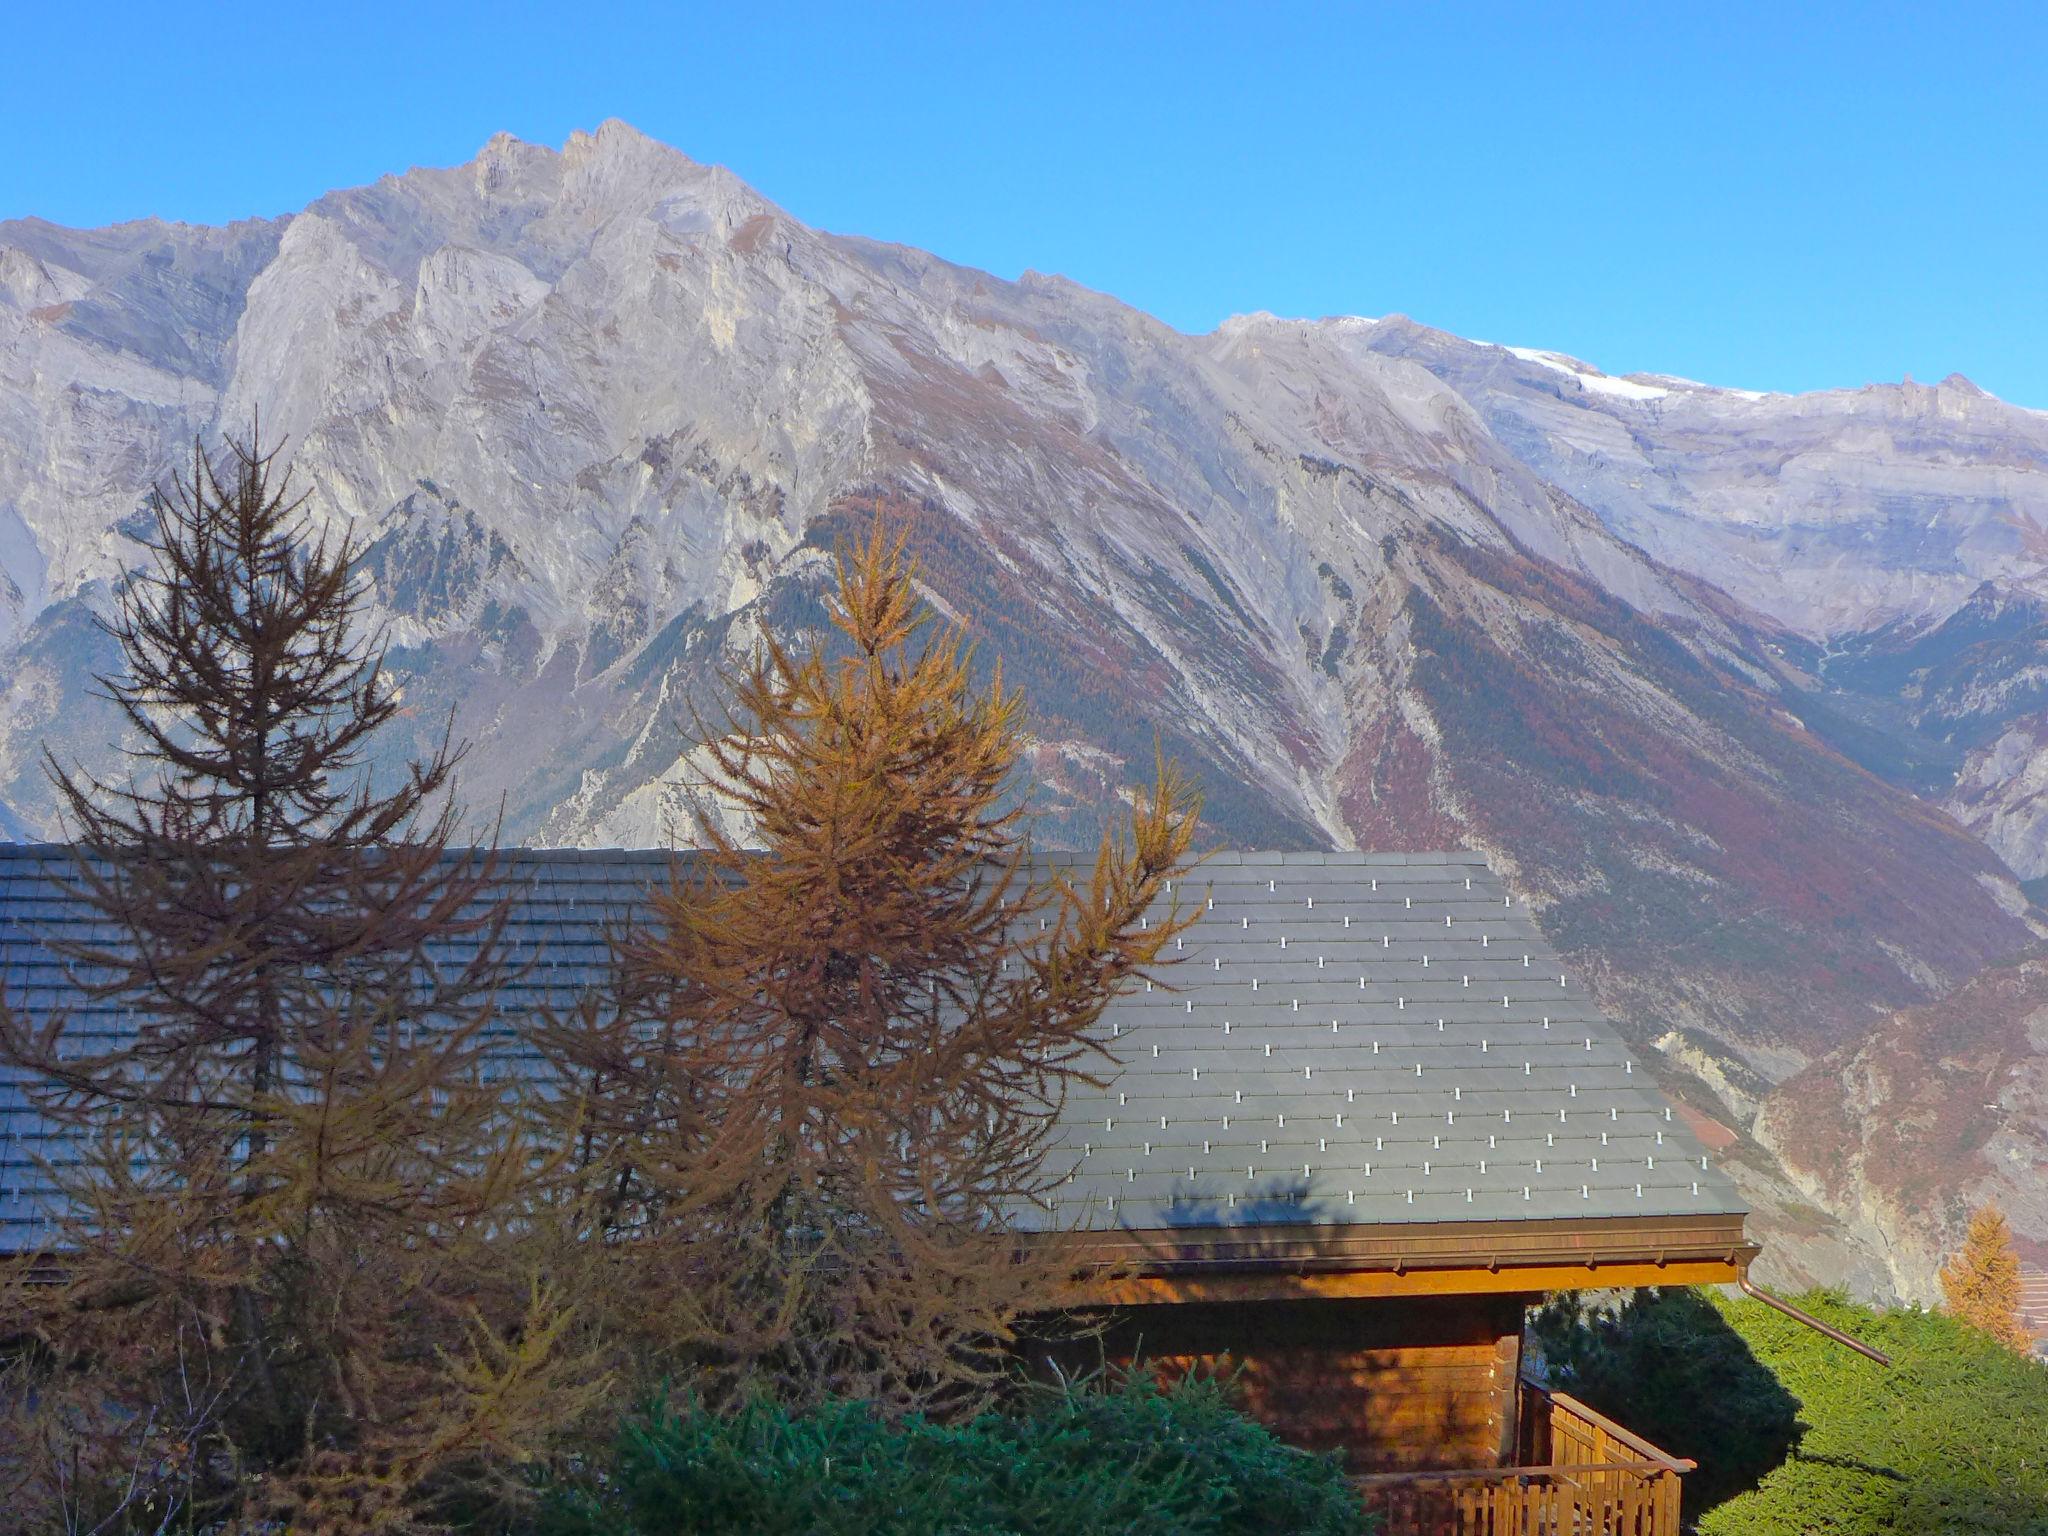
top-left (1343, 326), bottom-right (2048, 879)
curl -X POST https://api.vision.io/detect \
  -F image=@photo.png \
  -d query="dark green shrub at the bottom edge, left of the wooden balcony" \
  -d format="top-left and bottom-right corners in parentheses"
top-left (543, 1374), bottom-right (1368, 1536)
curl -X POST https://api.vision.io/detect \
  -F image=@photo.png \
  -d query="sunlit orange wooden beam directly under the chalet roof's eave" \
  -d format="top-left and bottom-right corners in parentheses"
top-left (1081, 1260), bottom-right (1743, 1307)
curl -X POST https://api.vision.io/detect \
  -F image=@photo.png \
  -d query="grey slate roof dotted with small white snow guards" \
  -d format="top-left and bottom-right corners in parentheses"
top-left (0, 846), bottom-right (1743, 1249)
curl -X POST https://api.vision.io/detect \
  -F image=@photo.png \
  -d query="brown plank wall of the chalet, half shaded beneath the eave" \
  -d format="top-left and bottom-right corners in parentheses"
top-left (1057, 1296), bottom-right (1534, 1473)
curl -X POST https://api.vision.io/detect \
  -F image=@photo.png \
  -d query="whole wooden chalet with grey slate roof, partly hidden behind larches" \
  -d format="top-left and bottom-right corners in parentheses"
top-left (0, 846), bottom-right (1757, 1536)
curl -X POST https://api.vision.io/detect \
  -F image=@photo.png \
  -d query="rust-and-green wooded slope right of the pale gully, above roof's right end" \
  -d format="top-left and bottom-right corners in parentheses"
top-left (1348, 528), bottom-right (2017, 1075)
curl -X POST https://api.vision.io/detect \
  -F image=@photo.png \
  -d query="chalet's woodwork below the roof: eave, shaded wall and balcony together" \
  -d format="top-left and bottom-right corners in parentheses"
top-left (1040, 1214), bottom-right (1757, 1536)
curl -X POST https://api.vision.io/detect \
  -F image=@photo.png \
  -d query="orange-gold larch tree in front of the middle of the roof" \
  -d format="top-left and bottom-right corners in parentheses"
top-left (543, 522), bottom-right (1198, 1409)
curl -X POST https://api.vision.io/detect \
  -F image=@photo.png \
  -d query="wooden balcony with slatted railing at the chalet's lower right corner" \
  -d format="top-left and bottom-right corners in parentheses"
top-left (1356, 1382), bottom-right (1694, 1536)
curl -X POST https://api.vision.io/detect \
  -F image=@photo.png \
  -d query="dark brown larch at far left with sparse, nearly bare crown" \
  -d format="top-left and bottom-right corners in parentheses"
top-left (0, 440), bottom-right (590, 1532)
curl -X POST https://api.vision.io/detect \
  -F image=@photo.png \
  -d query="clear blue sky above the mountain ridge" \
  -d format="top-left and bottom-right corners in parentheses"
top-left (0, 0), bottom-right (2048, 408)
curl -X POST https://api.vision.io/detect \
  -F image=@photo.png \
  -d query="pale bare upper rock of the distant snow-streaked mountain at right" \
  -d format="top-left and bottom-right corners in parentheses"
top-left (1372, 319), bottom-right (2048, 641)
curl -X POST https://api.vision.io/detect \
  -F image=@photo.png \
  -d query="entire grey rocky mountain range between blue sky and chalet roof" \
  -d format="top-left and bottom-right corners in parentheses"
top-left (0, 123), bottom-right (2048, 1302)
